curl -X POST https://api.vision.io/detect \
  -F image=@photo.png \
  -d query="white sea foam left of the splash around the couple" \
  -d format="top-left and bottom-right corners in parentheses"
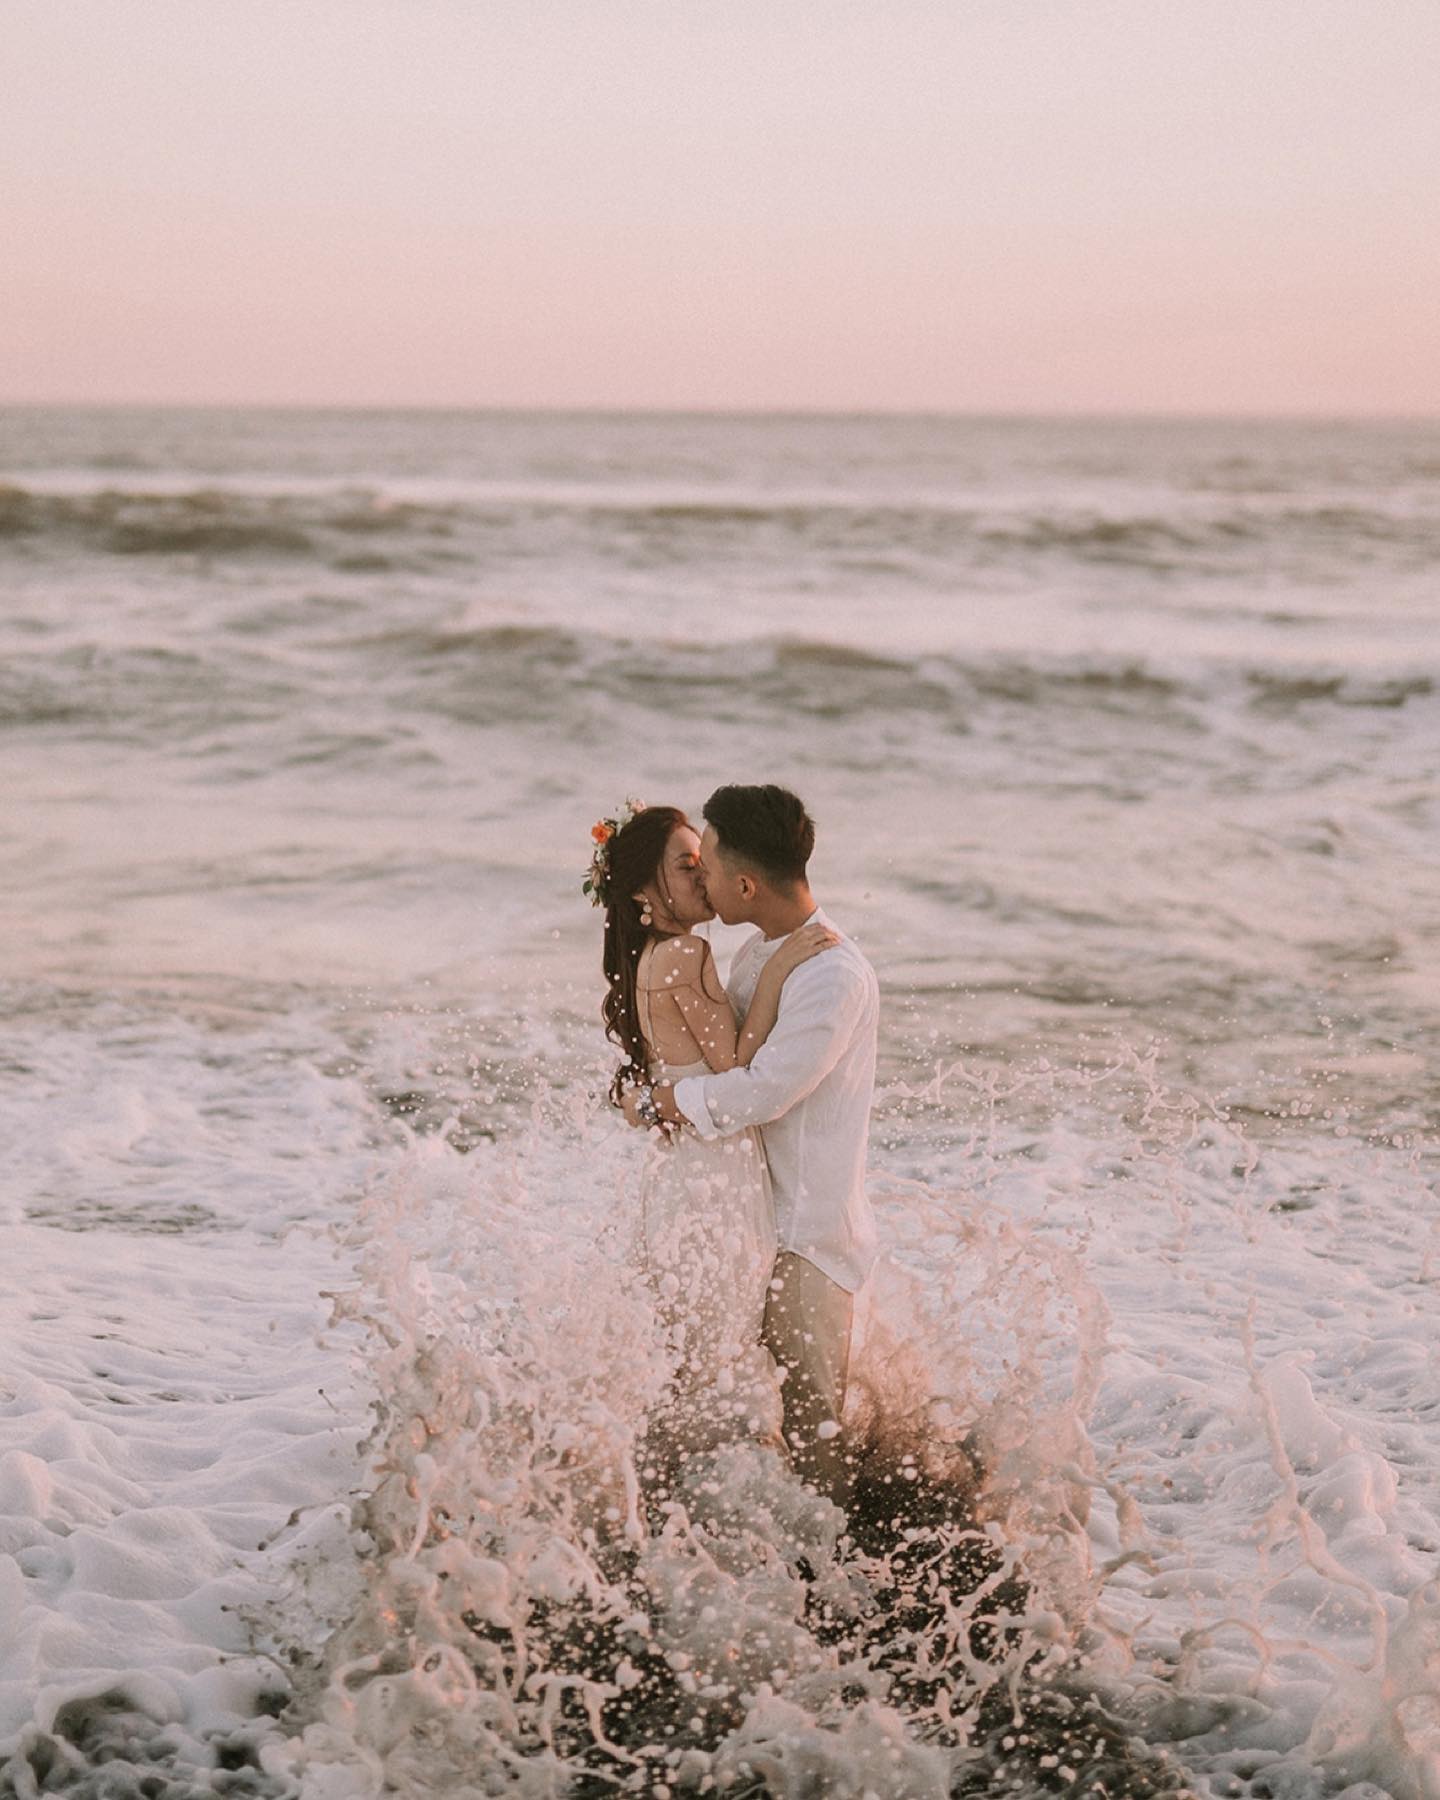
top-left (0, 1003), bottom-right (373, 1791)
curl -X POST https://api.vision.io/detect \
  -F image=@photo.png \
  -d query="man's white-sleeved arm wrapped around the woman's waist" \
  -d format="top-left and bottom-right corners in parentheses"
top-left (655, 954), bottom-right (866, 1138)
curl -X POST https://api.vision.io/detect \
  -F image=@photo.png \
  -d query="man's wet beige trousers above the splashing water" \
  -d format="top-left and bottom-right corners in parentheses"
top-left (760, 1249), bottom-right (855, 1501)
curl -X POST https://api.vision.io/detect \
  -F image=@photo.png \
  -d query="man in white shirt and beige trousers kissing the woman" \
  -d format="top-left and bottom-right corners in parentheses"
top-left (626, 787), bottom-right (880, 1499)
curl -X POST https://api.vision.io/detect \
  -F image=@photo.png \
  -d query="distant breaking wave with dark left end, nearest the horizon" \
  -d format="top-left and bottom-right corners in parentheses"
top-left (0, 482), bottom-right (1440, 580)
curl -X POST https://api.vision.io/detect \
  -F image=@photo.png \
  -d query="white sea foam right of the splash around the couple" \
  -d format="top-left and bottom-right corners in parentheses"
top-left (999, 1080), bottom-right (1440, 1800)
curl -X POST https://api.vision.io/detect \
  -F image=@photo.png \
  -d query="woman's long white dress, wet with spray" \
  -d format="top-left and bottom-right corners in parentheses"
top-left (639, 964), bottom-right (779, 1454)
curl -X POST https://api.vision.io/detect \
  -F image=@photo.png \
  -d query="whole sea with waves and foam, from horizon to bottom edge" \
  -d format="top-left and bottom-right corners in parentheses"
top-left (0, 410), bottom-right (1440, 1800)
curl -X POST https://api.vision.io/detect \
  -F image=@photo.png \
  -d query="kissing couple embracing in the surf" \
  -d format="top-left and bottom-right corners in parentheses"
top-left (585, 785), bottom-right (880, 1501)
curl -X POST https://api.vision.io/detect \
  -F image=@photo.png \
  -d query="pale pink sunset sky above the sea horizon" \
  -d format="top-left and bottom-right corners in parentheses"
top-left (0, 0), bottom-right (1440, 414)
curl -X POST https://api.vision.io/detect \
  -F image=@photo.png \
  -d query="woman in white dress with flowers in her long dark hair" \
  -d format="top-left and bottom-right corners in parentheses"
top-left (585, 801), bottom-right (837, 1454)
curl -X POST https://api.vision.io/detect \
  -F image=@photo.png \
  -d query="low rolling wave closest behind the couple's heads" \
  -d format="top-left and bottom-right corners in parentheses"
top-left (0, 619), bottom-right (1440, 765)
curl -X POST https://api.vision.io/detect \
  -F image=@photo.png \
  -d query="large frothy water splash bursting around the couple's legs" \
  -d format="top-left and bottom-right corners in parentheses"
top-left (266, 1105), bottom-right (1195, 1796)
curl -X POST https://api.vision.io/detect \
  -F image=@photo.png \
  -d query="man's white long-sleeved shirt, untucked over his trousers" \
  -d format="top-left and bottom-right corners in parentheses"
top-left (675, 909), bottom-right (880, 1294)
